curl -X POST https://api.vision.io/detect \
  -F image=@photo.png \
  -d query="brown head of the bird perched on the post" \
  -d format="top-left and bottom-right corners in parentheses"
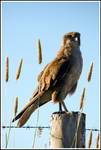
top-left (62, 32), bottom-right (80, 46)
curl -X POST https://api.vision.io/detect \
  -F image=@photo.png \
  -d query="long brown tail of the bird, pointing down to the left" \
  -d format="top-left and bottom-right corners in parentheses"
top-left (12, 91), bottom-right (51, 127)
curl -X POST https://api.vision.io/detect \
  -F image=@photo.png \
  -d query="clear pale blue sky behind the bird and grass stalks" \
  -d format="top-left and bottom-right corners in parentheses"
top-left (2, 2), bottom-right (100, 148)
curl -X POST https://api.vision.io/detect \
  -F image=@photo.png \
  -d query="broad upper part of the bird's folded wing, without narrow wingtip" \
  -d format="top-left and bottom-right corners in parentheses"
top-left (39, 56), bottom-right (73, 91)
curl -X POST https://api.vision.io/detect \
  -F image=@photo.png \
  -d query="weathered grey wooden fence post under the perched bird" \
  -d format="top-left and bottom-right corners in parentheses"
top-left (50, 112), bottom-right (86, 148)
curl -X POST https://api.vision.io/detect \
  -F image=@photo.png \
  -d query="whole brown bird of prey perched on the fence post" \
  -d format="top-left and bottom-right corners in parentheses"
top-left (12, 32), bottom-right (83, 127)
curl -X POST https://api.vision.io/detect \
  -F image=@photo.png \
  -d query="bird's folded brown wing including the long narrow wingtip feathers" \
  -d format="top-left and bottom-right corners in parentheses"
top-left (25, 54), bottom-right (73, 108)
